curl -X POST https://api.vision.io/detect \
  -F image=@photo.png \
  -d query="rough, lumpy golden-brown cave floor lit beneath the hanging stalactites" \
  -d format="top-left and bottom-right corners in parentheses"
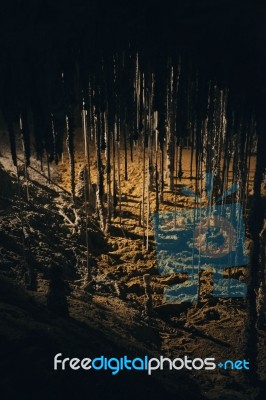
top-left (0, 130), bottom-right (266, 400)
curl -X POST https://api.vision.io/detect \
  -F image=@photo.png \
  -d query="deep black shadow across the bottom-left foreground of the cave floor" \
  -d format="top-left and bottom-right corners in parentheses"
top-left (0, 281), bottom-right (205, 400)
